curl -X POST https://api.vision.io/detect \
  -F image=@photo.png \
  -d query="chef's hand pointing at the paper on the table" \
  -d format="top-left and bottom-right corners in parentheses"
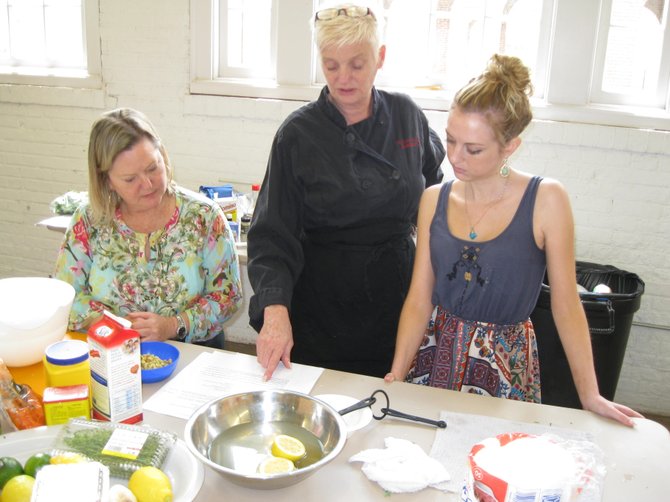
top-left (256, 305), bottom-right (293, 380)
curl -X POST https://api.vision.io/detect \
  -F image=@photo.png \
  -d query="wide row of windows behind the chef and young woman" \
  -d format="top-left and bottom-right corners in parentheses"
top-left (191, 0), bottom-right (670, 129)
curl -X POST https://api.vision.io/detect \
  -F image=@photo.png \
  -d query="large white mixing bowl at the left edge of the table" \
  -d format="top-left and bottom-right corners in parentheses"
top-left (0, 277), bottom-right (75, 366)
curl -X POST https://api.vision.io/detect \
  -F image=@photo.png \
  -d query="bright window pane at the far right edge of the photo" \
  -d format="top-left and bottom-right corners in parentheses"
top-left (602, 0), bottom-right (667, 94)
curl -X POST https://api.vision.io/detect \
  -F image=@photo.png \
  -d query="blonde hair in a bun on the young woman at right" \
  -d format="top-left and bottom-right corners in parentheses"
top-left (451, 54), bottom-right (533, 146)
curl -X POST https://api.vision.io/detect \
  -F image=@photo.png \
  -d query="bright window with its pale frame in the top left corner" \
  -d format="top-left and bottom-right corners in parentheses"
top-left (0, 0), bottom-right (100, 87)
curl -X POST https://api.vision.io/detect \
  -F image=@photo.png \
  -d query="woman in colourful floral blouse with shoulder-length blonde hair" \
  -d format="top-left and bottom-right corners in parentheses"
top-left (55, 108), bottom-right (242, 347)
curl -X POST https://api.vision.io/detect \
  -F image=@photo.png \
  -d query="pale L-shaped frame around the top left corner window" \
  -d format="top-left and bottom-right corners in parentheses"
top-left (0, 0), bottom-right (102, 89)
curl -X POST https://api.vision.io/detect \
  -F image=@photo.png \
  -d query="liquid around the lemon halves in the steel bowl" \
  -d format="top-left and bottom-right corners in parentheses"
top-left (207, 421), bottom-right (324, 474)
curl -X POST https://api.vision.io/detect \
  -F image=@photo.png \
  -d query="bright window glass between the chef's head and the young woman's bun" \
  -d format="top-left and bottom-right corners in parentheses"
top-left (317, 0), bottom-right (548, 94)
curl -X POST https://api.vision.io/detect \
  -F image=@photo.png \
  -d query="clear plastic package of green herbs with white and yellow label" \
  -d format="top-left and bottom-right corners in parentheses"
top-left (52, 418), bottom-right (177, 479)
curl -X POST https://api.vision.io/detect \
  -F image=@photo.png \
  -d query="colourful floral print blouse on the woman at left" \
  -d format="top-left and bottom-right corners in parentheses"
top-left (55, 187), bottom-right (242, 342)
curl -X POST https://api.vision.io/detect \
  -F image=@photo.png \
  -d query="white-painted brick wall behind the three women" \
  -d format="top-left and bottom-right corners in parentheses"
top-left (0, 0), bottom-right (670, 415)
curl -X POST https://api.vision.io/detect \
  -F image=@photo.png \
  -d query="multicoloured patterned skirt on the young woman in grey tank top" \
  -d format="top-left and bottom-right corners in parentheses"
top-left (407, 306), bottom-right (541, 403)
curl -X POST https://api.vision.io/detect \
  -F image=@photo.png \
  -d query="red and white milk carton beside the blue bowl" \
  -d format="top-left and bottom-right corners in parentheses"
top-left (88, 311), bottom-right (143, 424)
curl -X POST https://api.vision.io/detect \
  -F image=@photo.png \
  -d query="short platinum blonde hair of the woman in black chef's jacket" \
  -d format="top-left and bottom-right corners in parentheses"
top-left (310, 3), bottom-right (381, 52)
